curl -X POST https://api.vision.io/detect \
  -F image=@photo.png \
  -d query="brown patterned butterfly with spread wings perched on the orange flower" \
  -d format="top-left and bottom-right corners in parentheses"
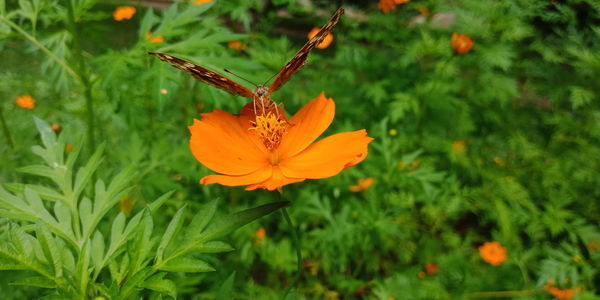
top-left (148, 8), bottom-right (344, 114)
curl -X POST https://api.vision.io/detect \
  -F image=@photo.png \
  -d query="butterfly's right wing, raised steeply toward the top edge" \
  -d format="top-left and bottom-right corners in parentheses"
top-left (269, 7), bottom-right (344, 93)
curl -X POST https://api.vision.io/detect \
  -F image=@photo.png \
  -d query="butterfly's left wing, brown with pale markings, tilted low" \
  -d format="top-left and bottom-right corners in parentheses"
top-left (148, 52), bottom-right (254, 98)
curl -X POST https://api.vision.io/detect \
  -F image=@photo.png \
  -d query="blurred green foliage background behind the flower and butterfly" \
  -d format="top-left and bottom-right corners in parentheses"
top-left (0, 0), bottom-right (600, 300)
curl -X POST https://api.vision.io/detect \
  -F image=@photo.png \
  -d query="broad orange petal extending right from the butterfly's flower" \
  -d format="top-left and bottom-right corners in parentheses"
top-left (279, 129), bottom-right (373, 179)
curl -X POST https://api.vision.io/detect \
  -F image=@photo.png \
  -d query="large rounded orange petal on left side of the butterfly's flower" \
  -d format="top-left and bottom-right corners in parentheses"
top-left (188, 109), bottom-right (268, 175)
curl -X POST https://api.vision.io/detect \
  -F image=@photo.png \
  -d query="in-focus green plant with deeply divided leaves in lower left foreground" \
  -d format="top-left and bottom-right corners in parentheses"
top-left (0, 119), bottom-right (287, 299)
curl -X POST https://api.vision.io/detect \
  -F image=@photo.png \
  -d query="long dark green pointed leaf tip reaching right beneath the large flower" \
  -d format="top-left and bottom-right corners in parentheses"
top-left (199, 201), bottom-right (290, 241)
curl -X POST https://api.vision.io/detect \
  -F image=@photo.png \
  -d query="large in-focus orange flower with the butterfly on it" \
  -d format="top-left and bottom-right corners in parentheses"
top-left (189, 93), bottom-right (373, 191)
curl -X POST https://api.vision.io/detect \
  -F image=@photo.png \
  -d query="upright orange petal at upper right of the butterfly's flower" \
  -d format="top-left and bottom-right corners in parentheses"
top-left (278, 92), bottom-right (335, 158)
